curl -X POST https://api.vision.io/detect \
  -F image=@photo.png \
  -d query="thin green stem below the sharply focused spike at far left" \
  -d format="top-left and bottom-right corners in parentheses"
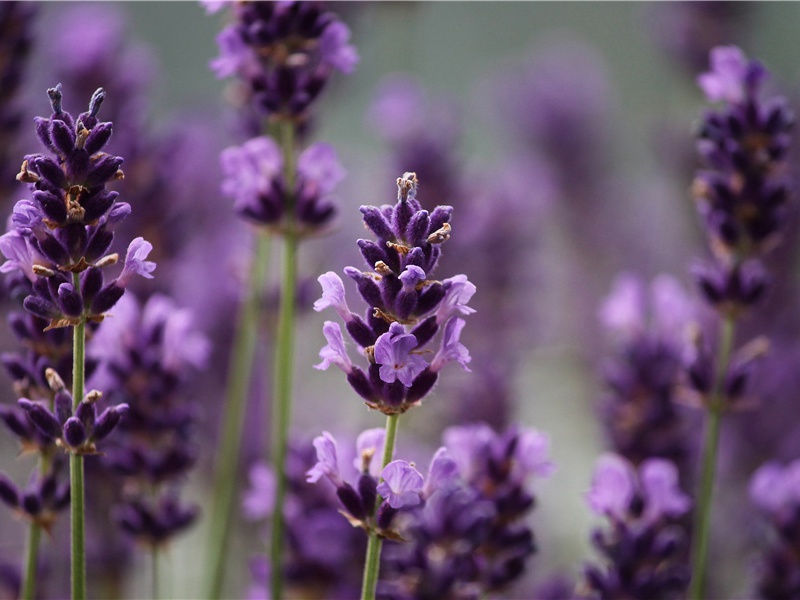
top-left (69, 273), bottom-right (86, 600)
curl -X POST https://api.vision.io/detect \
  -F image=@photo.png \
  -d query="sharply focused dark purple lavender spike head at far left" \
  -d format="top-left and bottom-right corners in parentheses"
top-left (0, 84), bottom-right (155, 328)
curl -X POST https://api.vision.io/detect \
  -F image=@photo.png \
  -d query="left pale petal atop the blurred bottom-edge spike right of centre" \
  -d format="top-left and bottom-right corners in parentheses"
top-left (586, 454), bottom-right (636, 521)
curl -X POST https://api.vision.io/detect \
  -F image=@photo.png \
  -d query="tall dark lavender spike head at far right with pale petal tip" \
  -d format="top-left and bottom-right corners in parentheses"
top-left (692, 46), bottom-right (794, 288)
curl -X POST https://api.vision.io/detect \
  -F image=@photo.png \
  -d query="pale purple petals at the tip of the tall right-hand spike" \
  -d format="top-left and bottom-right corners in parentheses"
top-left (697, 46), bottom-right (767, 104)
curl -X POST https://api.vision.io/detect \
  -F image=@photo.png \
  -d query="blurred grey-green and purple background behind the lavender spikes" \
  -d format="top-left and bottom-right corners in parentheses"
top-left (0, 2), bottom-right (800, 598)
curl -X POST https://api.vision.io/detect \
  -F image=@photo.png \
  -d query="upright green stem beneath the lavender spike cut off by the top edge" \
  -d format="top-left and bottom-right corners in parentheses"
top-left (270, 122), bottom-right (299, 598)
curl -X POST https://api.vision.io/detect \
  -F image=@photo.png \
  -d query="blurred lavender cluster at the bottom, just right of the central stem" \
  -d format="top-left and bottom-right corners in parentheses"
top-left (378, 424), bottom-right (553, 598)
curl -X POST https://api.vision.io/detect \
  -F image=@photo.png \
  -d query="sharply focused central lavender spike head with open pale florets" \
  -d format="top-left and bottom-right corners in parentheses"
top-left (314, 173), bottom-right (475, 414)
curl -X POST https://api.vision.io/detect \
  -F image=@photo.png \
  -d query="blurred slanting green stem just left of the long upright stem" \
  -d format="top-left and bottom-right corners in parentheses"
top-left (207, 233), bottom-right (270, 599)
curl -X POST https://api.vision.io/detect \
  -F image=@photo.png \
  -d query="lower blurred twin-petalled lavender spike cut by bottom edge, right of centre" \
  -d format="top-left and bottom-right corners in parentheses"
top-left (585, 454), bottom-right (691, 599)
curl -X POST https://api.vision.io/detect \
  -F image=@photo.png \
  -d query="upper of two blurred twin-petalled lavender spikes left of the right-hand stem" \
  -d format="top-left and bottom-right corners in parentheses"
top-left (599, 274), bottom-right (698, 478)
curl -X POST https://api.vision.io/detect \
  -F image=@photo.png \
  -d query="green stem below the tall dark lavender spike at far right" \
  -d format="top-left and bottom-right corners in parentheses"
top-left (689, 316), bottom-right (735, 600)
